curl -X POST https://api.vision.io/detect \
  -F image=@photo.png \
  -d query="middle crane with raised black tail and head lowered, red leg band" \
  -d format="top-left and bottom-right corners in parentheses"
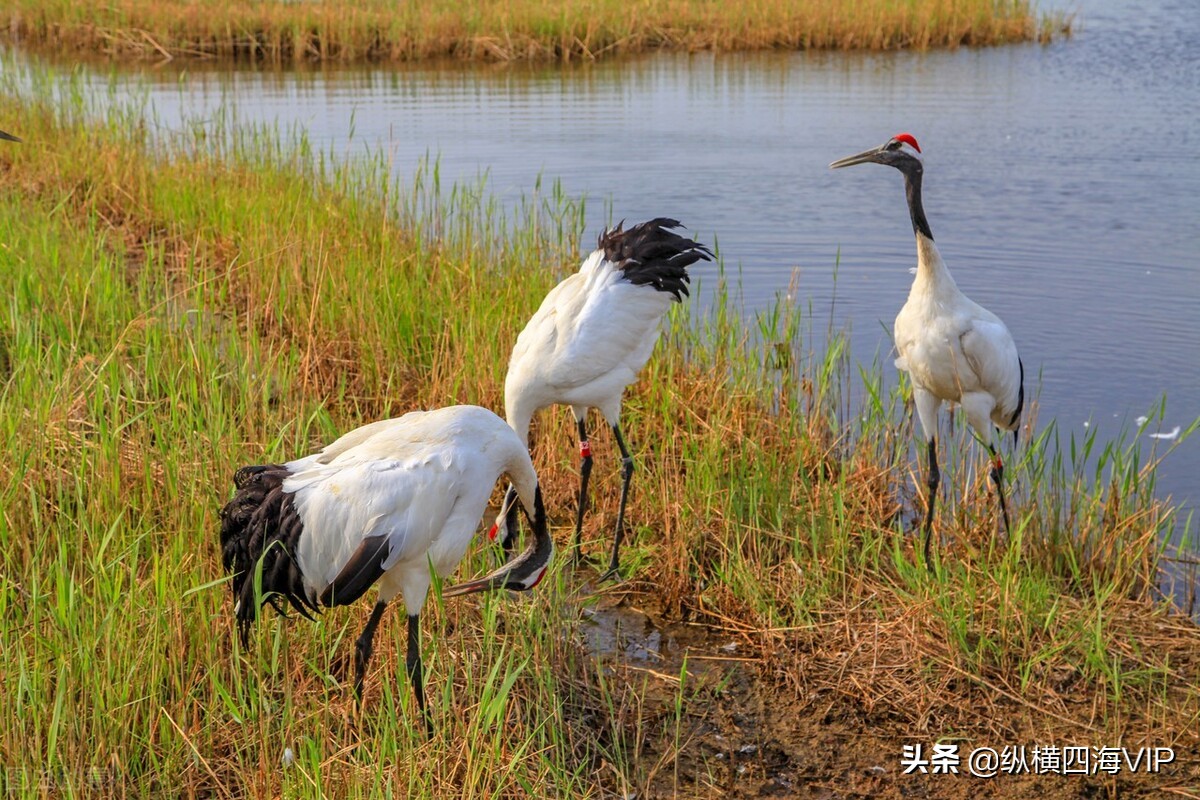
top-left (491, 217), bottom-right (713, 577)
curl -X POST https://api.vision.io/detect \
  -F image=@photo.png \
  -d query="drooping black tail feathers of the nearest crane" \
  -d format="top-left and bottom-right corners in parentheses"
top-left (221, 464), bottom-right (317, 644)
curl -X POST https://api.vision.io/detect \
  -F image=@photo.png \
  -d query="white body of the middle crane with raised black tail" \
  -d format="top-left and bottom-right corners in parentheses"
top-left (504, 249), bottom-right (674, 441)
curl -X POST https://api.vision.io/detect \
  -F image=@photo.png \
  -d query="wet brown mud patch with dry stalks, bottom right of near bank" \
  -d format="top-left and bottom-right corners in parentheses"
top-left (576, 588), bottom-right (1200, 800)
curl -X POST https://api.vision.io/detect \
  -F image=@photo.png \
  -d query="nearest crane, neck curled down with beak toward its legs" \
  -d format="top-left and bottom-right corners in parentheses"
top-left (221, 405), bottom-right (554, 732)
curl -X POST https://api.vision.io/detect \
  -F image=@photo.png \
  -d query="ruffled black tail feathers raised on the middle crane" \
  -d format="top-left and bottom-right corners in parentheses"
top-left (596, 217), bottom-right (713, 300)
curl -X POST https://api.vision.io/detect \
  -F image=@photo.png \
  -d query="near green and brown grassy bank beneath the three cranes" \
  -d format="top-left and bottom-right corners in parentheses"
top-left (0, 76), bottom-right (1200, 798)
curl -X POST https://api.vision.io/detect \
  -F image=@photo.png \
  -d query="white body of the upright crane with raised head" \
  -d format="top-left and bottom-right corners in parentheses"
top-left (893, 233), bottom-right (1021, 444)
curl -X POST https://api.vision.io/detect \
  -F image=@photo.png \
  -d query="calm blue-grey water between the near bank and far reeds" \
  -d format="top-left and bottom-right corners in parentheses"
top-left (4, 0), bottom-right (1200, 525)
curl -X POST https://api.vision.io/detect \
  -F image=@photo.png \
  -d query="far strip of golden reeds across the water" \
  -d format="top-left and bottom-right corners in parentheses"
top-left (0, 0), bottom-right (1069, 64)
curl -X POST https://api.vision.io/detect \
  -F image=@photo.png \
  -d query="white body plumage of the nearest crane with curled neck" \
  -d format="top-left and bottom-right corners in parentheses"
top-left (283, 405), bottom-right (538, 614)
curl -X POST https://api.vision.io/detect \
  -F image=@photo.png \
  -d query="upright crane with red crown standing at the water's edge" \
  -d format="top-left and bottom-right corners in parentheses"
top-left (829, 133), bottom-right (1025, 569)
